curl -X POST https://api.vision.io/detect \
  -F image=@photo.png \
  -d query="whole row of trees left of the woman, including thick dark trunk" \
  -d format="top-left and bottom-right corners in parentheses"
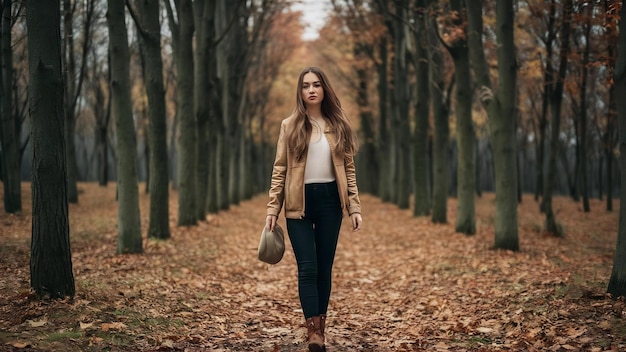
top-left (1, 0), bottom-right (300, 297)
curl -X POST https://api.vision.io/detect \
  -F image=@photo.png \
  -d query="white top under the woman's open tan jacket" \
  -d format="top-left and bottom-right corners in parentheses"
top-left (304, 129), bottom-right (335, 184)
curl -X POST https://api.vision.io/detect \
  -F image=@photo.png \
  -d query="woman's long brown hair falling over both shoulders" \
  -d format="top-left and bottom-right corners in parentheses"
top-left (288, 66), bottom-right (359, 160)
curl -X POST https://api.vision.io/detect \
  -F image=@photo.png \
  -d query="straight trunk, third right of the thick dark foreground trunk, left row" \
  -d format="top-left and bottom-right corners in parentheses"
top-left (168, 0), bottom-right (198, 226)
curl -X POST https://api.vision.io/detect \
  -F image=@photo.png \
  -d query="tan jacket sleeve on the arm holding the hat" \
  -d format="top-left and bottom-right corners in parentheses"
top-left (267, 121), bottom-right (287, 216)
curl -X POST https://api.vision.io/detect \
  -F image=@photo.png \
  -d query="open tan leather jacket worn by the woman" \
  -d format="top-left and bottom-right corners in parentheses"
top-left (267, 117), bottom-right (361, 219)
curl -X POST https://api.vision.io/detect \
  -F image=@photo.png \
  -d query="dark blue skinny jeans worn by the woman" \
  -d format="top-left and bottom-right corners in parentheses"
top-left (287, 182), bottom-right (342, 319)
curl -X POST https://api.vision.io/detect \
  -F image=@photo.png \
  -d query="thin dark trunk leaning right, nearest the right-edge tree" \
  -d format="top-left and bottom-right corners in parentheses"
top-left (543, 0), bottom-right (572, 237)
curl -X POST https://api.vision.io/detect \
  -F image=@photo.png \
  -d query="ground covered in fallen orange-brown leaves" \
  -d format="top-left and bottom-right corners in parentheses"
top-left (0, 184), bottom-right (626, 352)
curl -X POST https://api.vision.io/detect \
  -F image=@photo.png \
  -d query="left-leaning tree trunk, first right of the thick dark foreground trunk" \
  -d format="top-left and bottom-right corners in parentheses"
top-left (107, 0), bottom-right (143, 254)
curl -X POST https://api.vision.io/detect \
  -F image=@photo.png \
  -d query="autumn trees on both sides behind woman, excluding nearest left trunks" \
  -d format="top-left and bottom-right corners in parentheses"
top-left (0, 0), bottom-right (622, 249)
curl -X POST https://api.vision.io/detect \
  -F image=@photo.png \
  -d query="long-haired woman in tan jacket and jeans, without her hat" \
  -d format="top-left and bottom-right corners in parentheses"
top-left (266, 67), bottom-right (363, 351)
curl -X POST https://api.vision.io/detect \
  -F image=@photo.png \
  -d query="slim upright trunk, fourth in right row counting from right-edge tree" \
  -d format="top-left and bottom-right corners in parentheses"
top-left (427, 11), bottom-right (450, 223)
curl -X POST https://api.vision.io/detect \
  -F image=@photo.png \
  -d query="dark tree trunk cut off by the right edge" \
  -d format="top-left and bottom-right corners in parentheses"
top-left (607, 0), bottom-right (626, 298)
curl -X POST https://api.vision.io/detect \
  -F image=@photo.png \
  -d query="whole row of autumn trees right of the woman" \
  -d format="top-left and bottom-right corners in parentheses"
top-left (314, 0), bottom-right (622, 250)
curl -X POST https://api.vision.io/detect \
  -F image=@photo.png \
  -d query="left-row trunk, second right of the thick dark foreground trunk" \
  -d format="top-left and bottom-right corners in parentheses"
top-left (135, 0), bottom-right (170, 239)
